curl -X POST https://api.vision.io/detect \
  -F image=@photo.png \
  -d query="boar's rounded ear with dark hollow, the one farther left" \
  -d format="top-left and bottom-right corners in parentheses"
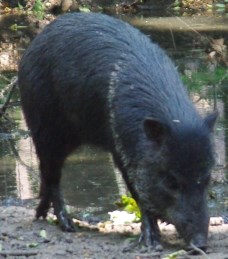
top-left (144, 118), bottom-right (169, 145)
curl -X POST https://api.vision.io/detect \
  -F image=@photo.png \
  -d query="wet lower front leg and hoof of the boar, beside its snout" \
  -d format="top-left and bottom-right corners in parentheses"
top-left (139, 212), bottom-right (162, 251)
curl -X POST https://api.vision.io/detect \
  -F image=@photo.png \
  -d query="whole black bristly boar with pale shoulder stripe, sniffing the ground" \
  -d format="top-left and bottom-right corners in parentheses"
top-left (19, 13), bottom-right (216, 252)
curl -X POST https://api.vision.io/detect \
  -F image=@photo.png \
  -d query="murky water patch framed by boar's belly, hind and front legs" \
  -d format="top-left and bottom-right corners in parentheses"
top-left (62, 147), bottom-right (124, 215)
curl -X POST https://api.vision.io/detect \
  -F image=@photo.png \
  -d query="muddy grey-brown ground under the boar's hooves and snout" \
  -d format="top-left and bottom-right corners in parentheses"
top-left (0, 206), bottom-right (228, 259)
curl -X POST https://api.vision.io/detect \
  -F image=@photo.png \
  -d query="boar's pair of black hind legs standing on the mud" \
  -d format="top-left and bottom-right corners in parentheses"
top-left (36, 139), bottom-right (75, 232)
